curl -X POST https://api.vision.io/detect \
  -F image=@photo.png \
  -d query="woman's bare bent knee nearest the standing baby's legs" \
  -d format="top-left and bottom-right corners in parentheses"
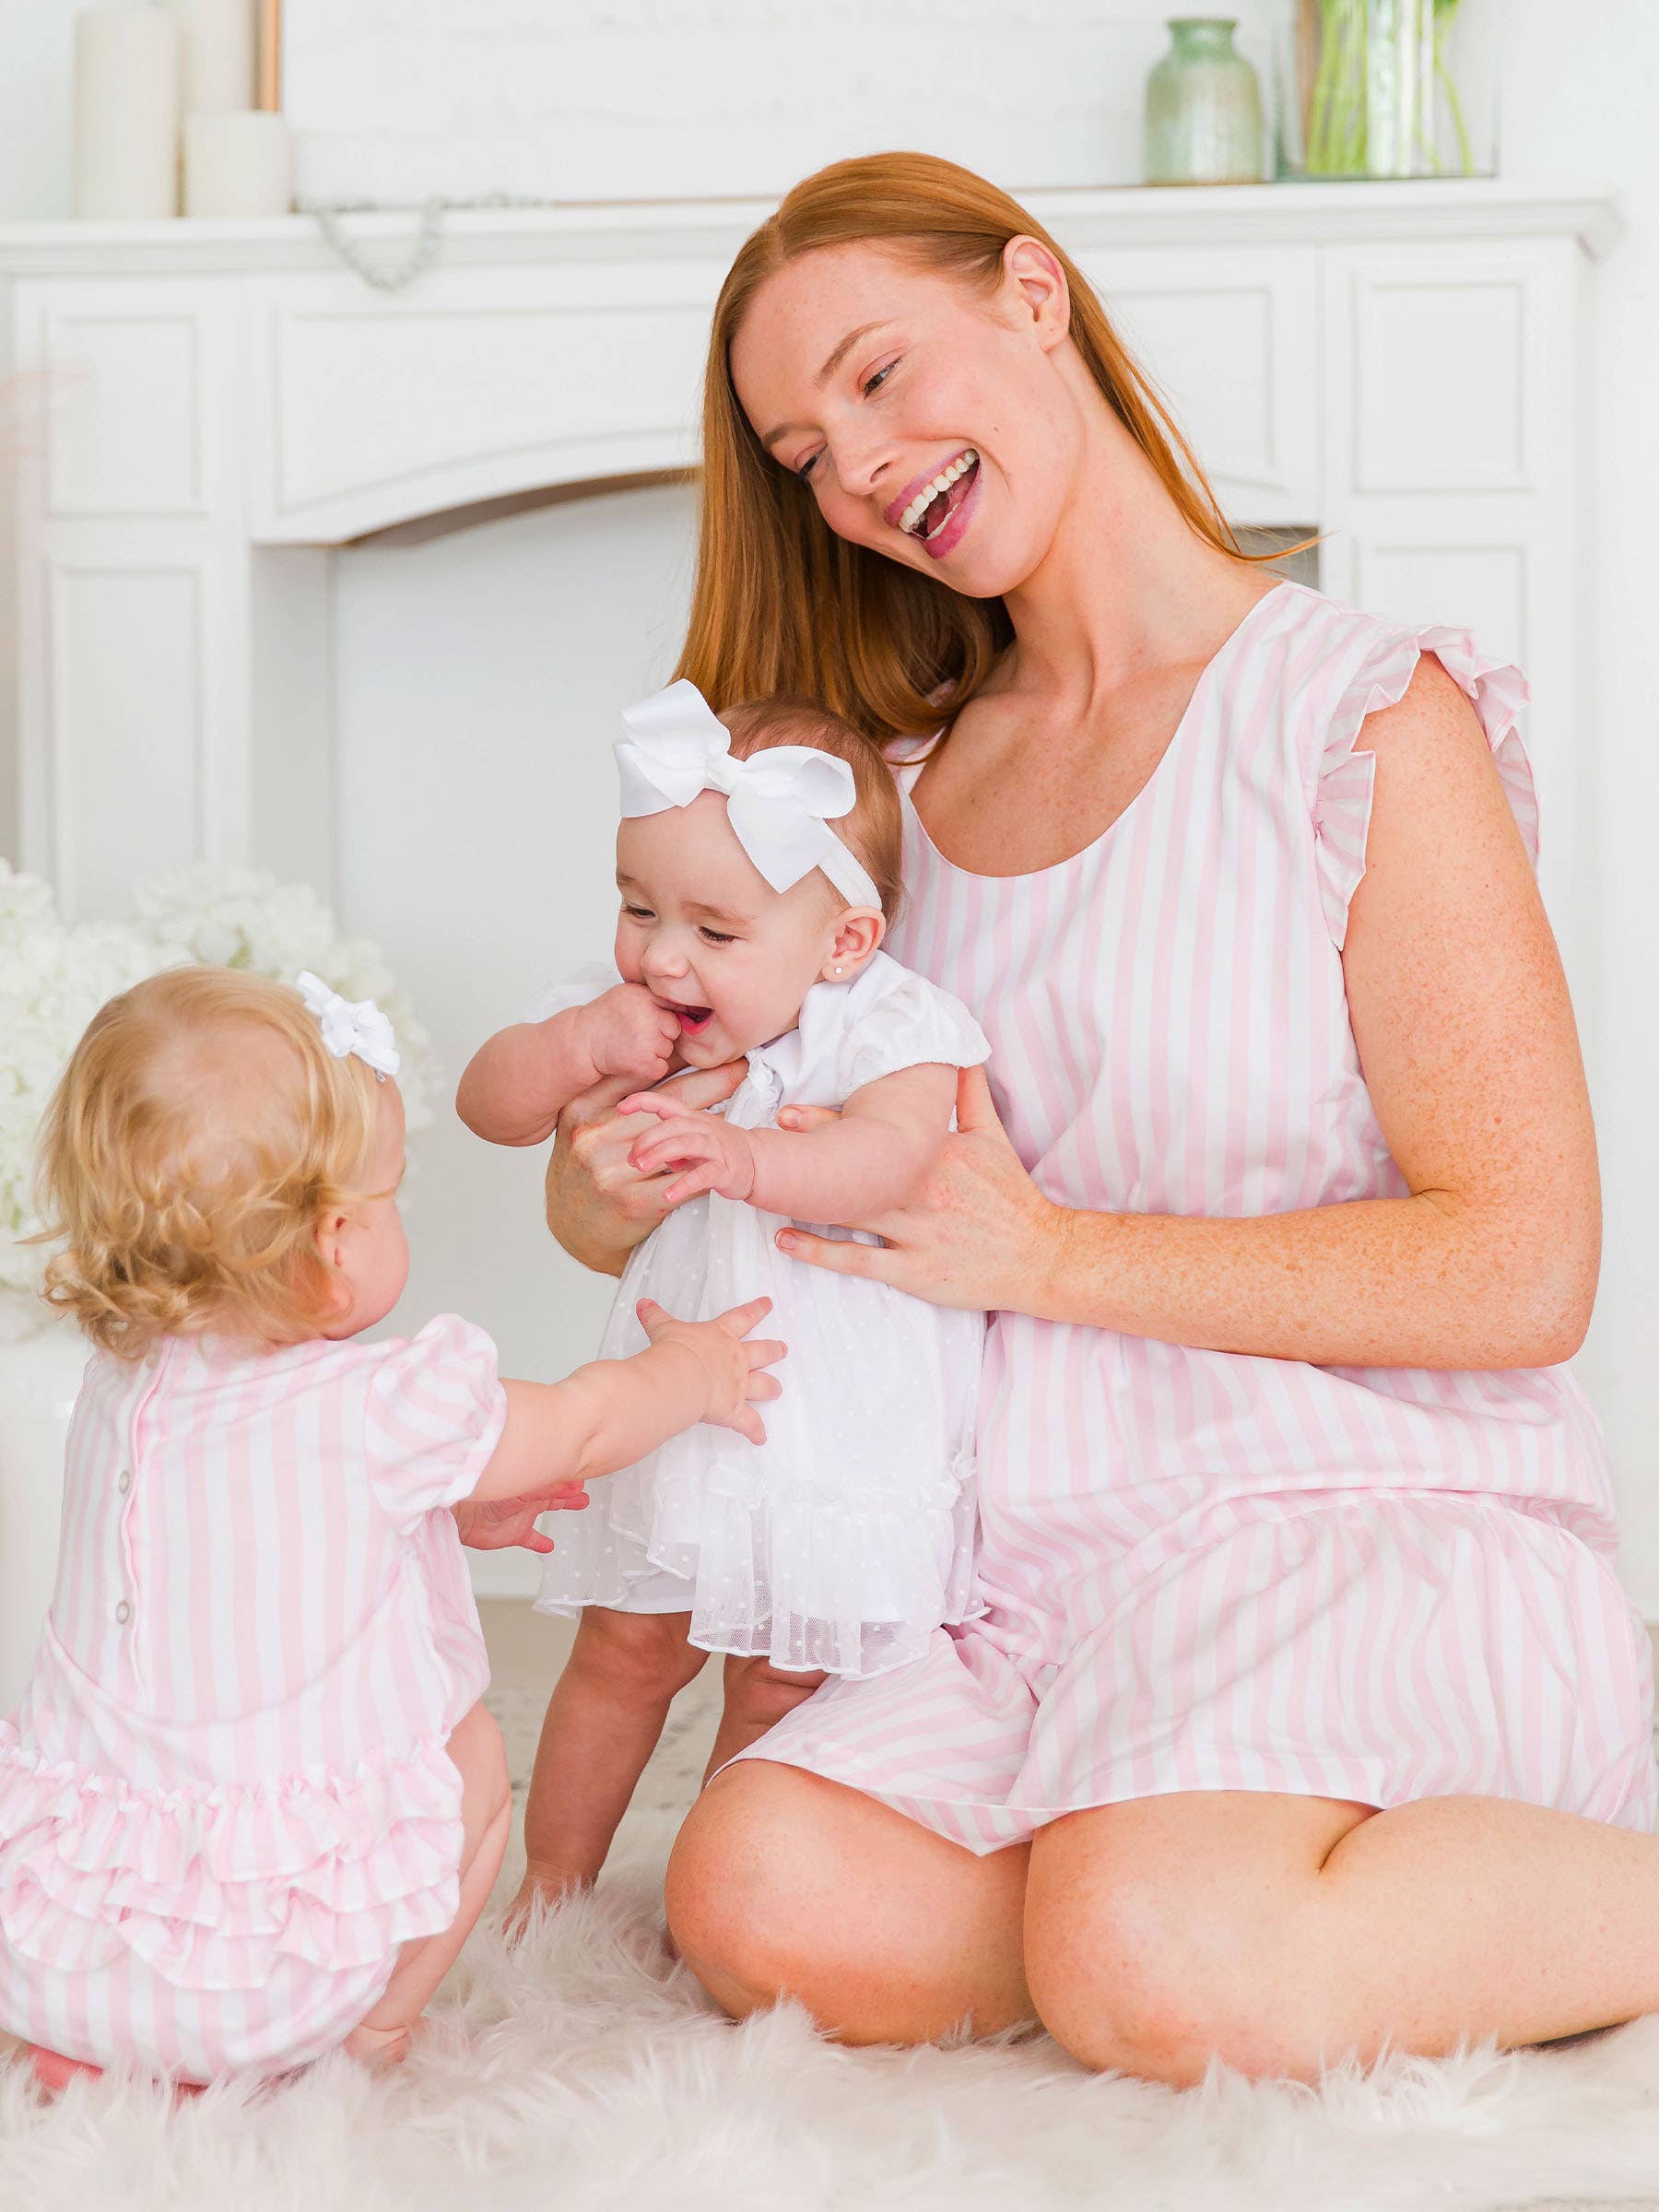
top-left (668, 1759), bottom-right (1030, 2044)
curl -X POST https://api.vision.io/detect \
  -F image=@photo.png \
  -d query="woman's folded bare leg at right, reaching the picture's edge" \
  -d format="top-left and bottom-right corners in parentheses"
top-left (1027, 1792), bottom-right (1659, 2084)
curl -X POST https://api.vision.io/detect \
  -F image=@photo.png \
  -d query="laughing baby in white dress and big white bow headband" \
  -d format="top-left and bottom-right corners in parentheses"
top-left (458, 679), bottom-right (989, 1909)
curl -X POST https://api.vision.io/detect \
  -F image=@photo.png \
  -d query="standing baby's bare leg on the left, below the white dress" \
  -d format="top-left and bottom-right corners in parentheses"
top-left (507, 1606), bottom-right (708, 1929)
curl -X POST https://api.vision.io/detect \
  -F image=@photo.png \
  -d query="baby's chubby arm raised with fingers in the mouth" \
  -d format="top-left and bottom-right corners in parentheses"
top-left (455, 982), bottom-right (679, 1144)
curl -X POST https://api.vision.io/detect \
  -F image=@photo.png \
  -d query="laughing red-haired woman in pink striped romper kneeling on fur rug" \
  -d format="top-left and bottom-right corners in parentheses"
top-left (511, 155), bottom-right (1659, 2081)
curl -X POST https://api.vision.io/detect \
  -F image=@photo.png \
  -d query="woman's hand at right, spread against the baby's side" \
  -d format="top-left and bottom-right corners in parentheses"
top-left (779, 1068), bottom-right (1068, 1312)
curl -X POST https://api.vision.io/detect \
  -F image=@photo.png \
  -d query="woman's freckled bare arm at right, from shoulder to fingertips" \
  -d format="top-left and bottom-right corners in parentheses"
top-left (790, 662), bottom-right (1599, 1367)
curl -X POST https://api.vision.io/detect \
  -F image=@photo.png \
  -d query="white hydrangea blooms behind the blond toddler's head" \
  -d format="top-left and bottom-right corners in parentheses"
top-left (0, 861), bottom-right (436, 1343)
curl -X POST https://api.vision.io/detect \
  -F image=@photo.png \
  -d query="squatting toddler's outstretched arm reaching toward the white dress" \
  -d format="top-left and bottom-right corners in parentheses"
top-left (471, 1299), bottom-right (783, 1504)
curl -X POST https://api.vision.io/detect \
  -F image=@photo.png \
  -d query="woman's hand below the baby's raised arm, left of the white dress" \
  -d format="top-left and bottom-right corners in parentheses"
top-left (547, 1060), bottom-right (747, 1274)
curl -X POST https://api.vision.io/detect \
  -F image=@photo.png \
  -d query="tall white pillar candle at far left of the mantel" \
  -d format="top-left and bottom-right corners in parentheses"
top-left (76, 6), bottom-right (179, 221)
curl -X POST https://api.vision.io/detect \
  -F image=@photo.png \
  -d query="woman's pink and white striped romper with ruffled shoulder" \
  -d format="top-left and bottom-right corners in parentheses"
top-left (750, 584), bottom-right (1654, 1852)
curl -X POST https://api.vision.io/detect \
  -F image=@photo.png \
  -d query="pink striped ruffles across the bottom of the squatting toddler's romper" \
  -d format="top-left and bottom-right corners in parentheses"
top-left (0, 1724), bottom-right (463, 1989)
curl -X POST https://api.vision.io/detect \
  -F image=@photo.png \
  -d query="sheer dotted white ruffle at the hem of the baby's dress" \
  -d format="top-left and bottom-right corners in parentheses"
top-left (537, 1447), bottom-right (984, 1679)
